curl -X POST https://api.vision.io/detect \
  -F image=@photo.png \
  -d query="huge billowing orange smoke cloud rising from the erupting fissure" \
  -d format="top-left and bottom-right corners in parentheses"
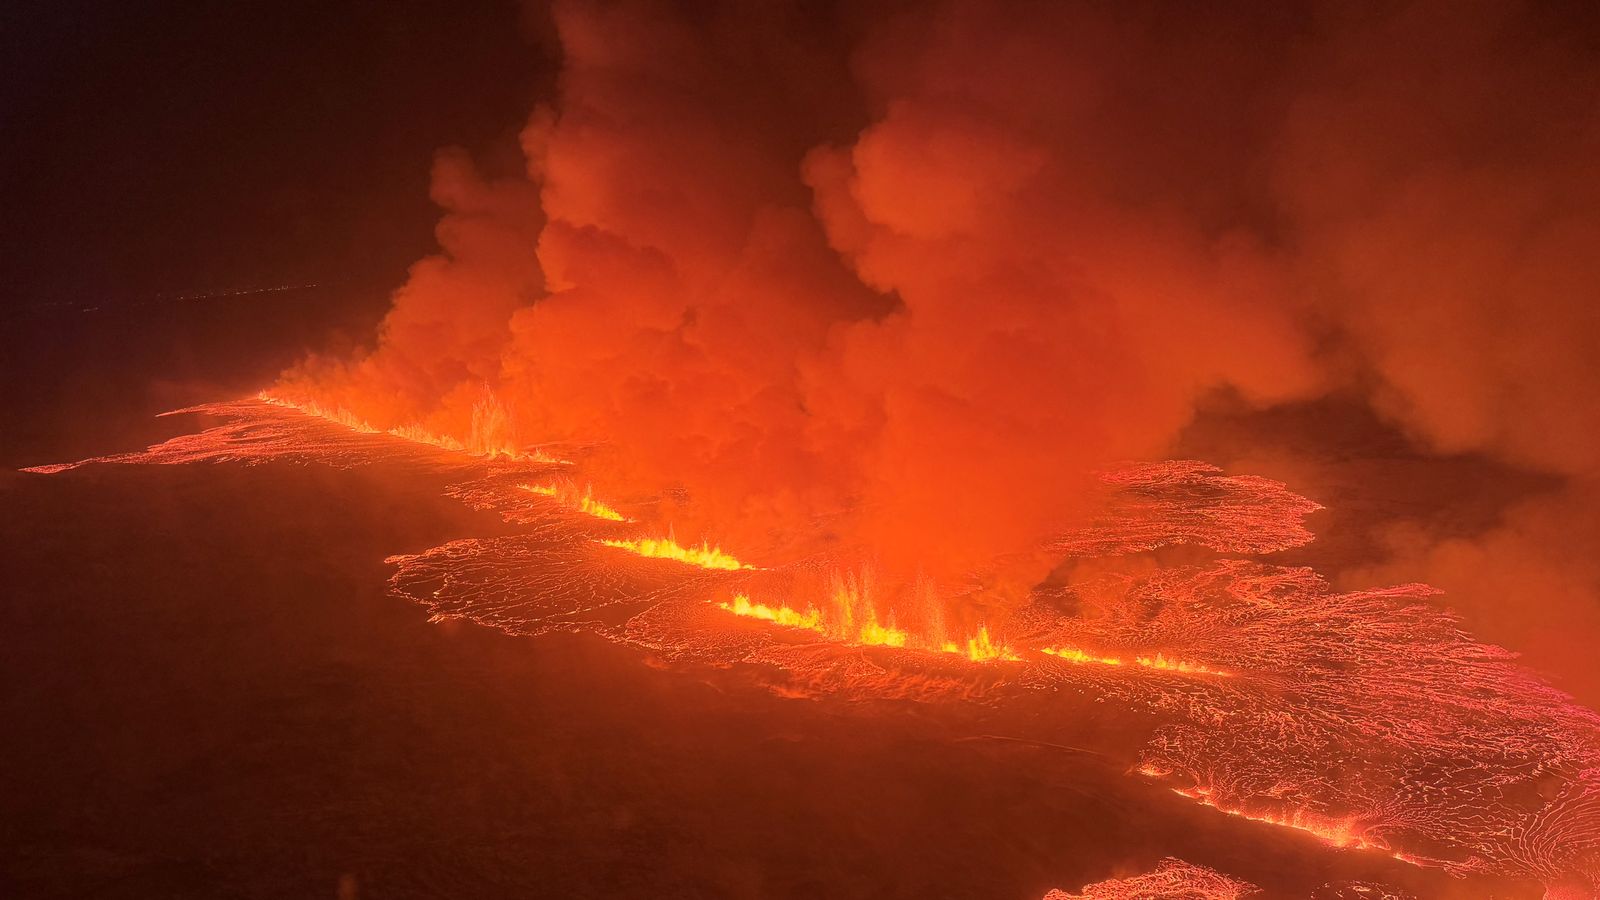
top-left (283, 0), bottom-right (1600, 659)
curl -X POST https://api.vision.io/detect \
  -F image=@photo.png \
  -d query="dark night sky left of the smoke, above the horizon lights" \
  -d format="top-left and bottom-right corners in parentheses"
top-left (0, 0), bottom-right (552, 311)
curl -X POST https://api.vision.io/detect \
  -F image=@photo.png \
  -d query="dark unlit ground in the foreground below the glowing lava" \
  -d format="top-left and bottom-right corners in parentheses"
top-left (0, 291), bottom-right (1536, 900)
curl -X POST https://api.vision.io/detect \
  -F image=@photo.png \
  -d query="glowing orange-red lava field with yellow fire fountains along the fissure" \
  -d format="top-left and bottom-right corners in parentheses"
top-left (34, 400), bottom-right (1600, 897)
